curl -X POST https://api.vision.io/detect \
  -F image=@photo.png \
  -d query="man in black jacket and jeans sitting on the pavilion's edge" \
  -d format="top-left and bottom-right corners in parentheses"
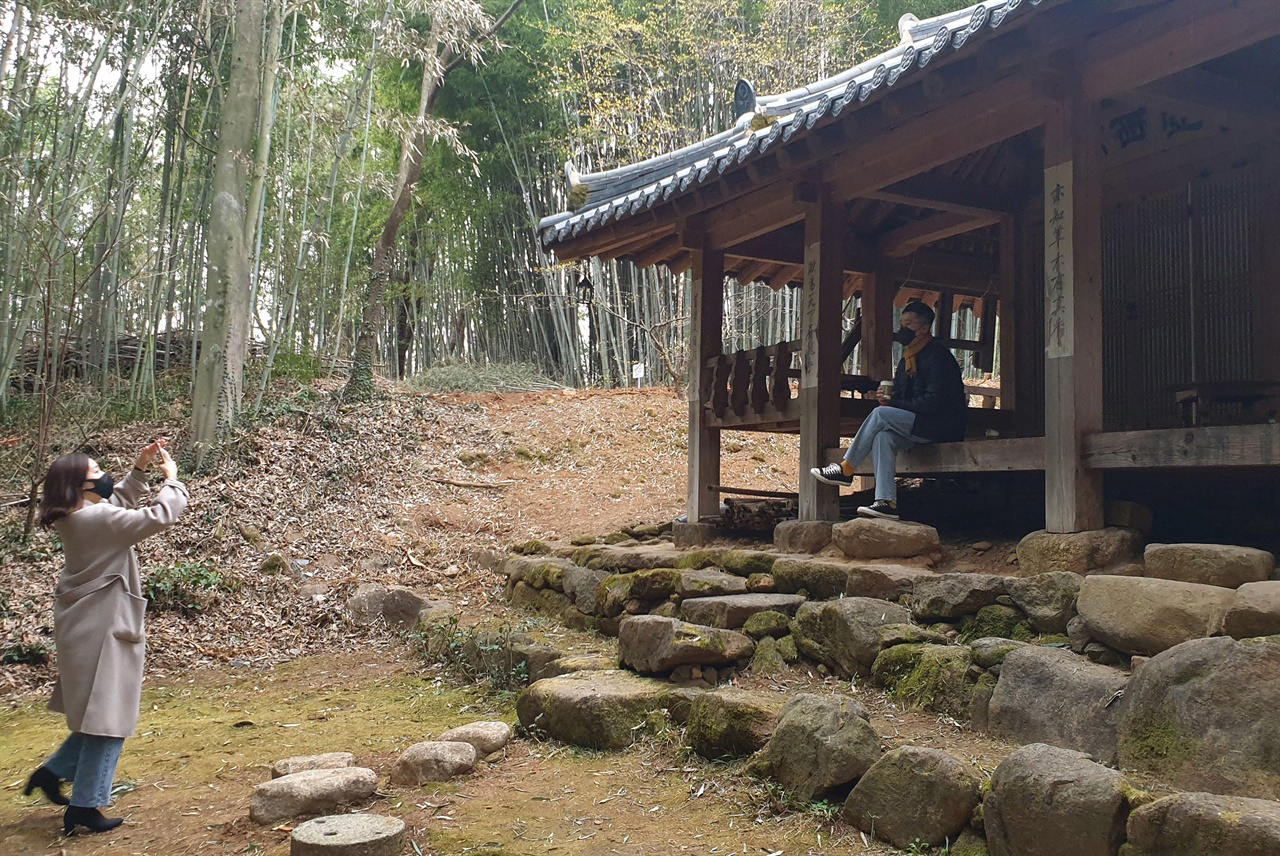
top-left (809, 302), bottom-right (969, 519)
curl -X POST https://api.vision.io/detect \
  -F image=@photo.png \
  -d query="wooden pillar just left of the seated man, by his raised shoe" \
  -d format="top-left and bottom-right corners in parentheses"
top-left (800, 193), bottom-right (844, 521)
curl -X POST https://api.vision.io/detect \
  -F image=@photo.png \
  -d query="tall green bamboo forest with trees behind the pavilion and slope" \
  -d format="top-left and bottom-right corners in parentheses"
top-left (0, 0), bottom-right (942, 454)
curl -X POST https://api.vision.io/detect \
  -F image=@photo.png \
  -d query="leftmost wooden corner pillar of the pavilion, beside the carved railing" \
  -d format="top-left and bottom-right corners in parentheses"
top-left (689, 243), bottom-right (724, 523)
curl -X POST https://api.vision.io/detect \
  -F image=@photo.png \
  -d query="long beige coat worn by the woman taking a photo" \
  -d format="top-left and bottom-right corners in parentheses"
top-left (49, 470), bottom-right (188, 737)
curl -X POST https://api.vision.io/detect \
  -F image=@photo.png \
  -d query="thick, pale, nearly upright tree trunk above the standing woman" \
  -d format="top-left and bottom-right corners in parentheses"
top-left (191, 0), bottom-right (262, 467)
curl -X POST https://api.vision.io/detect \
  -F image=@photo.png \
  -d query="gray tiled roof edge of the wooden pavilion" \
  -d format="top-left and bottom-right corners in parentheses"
top-left (538, 0), bottom-right (1043, 246)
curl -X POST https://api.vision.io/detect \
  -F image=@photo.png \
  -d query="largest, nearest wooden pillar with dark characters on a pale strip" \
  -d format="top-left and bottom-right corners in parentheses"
top-left (1044, 90), bottom-right (1102, 532)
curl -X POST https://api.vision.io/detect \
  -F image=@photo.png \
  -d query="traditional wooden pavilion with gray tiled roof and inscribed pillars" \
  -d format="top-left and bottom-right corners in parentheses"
top-left (539, 0), bottom-right (1280, 532)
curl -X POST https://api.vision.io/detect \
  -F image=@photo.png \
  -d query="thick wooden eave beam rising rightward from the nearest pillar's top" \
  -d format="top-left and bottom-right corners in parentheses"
top-left (1079, 0), bottom-right (1280, 101)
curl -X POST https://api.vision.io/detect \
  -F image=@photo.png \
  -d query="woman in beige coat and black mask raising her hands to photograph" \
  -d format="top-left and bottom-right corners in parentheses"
top-left (23, 440), bottom-right (188, 836)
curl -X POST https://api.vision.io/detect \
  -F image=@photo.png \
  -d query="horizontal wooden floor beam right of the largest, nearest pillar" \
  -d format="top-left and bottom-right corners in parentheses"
top-left (1084, 425), bottom-right (1280, 470)
